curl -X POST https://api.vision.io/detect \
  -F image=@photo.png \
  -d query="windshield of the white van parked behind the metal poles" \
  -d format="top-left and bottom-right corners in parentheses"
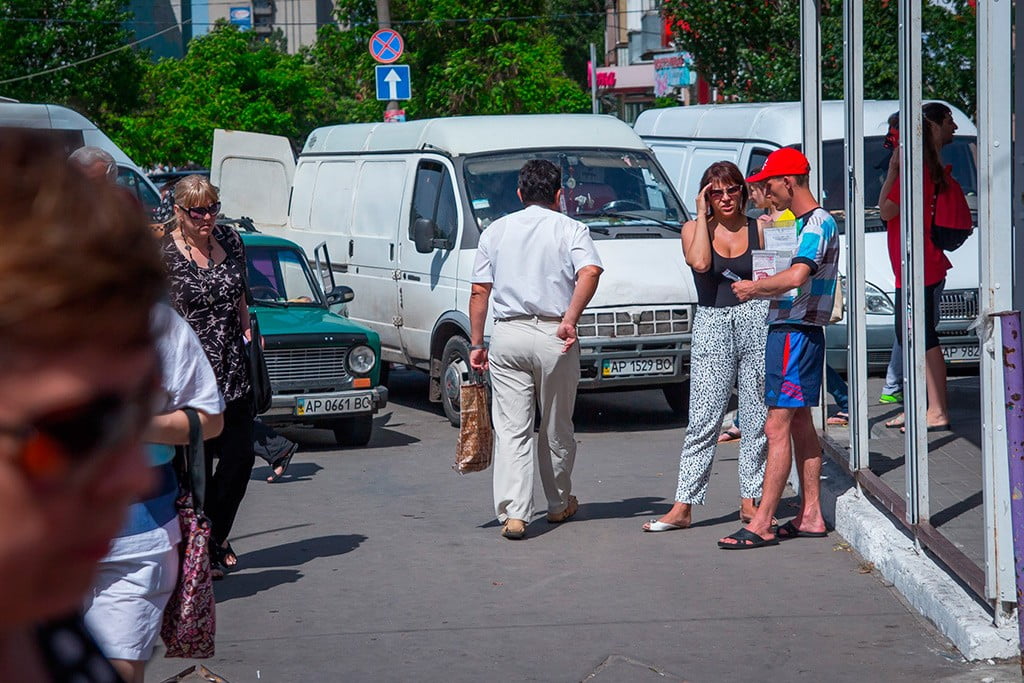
top-left (821, 135), bottom-right (978, 211)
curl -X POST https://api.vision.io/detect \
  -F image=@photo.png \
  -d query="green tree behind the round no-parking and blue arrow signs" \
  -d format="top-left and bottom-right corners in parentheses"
top-left (308, 0), bottom-right (589, 121)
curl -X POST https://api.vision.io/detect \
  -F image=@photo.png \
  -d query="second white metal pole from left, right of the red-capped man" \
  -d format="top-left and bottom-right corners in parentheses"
top-left (843, 2), bottom-right (870, 470)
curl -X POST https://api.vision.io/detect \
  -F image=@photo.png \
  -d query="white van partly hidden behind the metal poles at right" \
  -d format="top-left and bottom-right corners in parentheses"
top-left (634, 100), bottom-right (981, 371)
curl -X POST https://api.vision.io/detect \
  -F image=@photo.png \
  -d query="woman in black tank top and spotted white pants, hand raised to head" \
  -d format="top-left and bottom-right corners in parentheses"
top-left (643, 162), bottom-right (768, 531)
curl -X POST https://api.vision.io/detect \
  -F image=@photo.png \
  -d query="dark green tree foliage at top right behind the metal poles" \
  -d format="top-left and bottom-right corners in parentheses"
top-left (663, 0), bottom-right (975, 114)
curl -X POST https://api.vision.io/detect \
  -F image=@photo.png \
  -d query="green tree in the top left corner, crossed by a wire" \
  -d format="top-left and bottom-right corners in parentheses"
top-left (0, 0), bottom-right (148, 127)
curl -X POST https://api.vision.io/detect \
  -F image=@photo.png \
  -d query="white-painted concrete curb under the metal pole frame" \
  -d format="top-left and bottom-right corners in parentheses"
top-left (821, 437), bottom-right (1020, 661)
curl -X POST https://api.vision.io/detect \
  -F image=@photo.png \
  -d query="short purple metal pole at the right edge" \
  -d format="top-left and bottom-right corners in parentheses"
top-left (996, 310), bottom-right (1024, 676)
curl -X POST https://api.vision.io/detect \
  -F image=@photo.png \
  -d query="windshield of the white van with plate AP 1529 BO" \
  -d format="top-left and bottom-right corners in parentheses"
top-left (464, 150), bottom-right (686, 240)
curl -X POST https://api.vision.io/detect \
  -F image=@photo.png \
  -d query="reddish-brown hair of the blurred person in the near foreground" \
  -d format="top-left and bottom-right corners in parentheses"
top-left (0, 128), bottom-right (165, 360)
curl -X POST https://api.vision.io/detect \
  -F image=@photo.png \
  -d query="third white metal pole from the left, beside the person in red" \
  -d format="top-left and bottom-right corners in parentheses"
top-left (899, 0), bottom-right (931, 524)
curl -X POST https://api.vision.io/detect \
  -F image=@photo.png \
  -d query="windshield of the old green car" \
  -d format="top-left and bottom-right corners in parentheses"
top-left (246, 246), bottom-right (323, 306)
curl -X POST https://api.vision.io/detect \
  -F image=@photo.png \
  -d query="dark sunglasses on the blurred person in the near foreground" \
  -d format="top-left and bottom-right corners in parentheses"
top-left (0, 372), bottom-right (161, 477)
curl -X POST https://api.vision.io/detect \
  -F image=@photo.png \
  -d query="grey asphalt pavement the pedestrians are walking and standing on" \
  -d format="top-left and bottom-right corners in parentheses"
top-left (147, 371), bottom-right (1014, 683)
